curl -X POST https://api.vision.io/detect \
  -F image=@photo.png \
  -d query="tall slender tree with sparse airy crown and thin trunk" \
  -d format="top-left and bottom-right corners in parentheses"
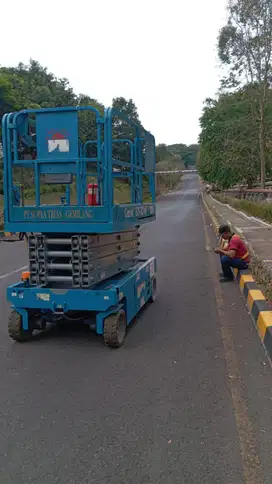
top-left (218, 0), bottom-right (272, 186)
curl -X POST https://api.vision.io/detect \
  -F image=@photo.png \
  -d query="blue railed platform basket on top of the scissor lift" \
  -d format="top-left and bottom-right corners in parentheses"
top-left (2, 106), bottom-right (156, 234)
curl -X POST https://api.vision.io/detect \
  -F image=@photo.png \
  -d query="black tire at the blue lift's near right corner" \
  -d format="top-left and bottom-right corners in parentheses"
top-left (104, 309), bottom-right (127, 348)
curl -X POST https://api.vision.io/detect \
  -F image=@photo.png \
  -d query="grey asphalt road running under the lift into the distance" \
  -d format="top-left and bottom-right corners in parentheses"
top-left (0, 175), bottom-right (272, 484)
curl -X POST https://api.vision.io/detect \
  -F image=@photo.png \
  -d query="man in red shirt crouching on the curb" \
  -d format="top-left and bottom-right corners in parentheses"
top-left (215, 225), bottom-right (250, 282)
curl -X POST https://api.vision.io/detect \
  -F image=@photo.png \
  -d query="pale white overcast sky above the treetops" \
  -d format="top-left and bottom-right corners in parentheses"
top-left (0, 0), bottom-right (227, 144)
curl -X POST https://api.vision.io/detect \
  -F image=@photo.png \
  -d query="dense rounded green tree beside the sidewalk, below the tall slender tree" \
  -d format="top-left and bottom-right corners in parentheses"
top-left (198, 87), bottom-right (272, 188)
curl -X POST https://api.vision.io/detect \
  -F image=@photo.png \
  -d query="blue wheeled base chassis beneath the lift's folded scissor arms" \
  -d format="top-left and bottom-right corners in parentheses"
top-left (7, 257), bottom-right (157, 348)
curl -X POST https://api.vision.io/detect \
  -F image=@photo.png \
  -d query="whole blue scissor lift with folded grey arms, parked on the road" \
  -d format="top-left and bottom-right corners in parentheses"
top-left (2, 106), bottom-right (156, 347)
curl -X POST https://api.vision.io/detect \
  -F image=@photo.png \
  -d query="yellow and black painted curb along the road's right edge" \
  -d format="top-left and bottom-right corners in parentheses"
top-left (202, 191), bottom-right (272, 359)
